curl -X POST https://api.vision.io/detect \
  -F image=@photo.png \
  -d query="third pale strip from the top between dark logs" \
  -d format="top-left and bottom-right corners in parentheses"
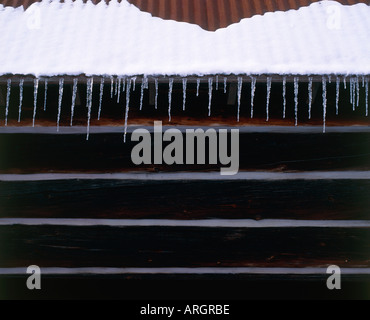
top-left (0, 218), bottom-right (370, 228)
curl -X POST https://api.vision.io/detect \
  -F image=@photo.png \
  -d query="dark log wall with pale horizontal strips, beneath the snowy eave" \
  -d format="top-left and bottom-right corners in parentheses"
top-left (0, 78), bottom-right (370, 299)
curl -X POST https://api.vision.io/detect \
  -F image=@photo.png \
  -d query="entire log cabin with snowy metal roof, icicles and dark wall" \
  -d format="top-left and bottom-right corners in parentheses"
top-left (0, 0), bottom-right (370, 299)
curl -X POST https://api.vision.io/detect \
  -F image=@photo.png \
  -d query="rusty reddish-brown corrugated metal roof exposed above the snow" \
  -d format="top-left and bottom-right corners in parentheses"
top-left (0, 0), bottom-right (370, 31)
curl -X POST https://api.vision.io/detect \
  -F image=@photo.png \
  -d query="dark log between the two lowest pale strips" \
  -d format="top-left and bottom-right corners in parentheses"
top-left (0, 226), bottom-right (370, 268)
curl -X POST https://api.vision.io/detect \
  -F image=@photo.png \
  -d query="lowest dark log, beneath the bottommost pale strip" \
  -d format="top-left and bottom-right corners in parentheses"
top-left (0, 274), bottom-right (370, 300)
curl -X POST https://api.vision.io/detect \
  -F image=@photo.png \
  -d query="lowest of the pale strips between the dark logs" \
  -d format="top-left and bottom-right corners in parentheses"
top-left (0, 267), bottom-right (370, 276)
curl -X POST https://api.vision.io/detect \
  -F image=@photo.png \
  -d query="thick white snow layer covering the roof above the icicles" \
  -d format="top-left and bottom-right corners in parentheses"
top-left (0, 0), bottom-right (370, 76)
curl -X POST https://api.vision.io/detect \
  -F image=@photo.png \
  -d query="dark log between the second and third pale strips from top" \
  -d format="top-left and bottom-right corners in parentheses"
top-left (0, 179), bottom-right (370, 220)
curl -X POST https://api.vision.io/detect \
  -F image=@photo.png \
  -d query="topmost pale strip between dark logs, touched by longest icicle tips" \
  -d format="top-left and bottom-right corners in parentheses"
top-left (0, 124), bottom-right (370, 135)
